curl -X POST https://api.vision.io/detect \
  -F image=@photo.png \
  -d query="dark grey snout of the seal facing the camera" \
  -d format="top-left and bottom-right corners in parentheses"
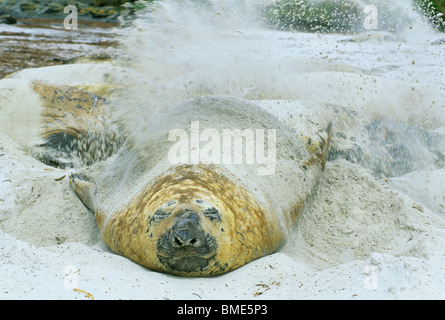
top-left (157, 209), bottom-right (216, 272)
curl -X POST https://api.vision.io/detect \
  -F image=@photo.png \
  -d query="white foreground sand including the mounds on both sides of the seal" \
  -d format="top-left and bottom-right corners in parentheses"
top-left (0, 128), bottom-right (445, 300)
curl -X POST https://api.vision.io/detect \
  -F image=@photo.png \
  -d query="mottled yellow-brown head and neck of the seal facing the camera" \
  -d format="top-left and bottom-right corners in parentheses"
top-left (96, 165), bottom-right (285, 276)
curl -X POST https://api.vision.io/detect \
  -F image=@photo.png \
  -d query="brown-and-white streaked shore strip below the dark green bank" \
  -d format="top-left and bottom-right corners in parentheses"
top-left (0, 18), bottom-right (116, 79)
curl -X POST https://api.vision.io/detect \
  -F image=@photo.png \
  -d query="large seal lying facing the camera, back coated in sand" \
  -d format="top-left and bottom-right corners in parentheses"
top-left (70, 97), bottom-right (330, 276)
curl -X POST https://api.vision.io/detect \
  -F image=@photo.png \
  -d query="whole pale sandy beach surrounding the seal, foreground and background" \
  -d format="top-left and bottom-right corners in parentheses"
top-left (0, 0), bottom-right (445, 301)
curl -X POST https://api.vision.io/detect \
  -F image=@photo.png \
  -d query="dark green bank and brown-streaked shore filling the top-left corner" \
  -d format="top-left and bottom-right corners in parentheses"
top-left (0, 0), bottom-right (132, 79)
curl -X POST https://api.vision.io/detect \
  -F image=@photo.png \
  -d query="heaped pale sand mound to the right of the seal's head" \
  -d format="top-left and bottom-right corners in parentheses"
top-left (283, 161), bottom-right (445, 269)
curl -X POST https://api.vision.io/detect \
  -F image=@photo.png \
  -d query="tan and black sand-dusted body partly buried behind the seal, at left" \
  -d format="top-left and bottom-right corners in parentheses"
top-left (32, 82), bottom-right (123, 168)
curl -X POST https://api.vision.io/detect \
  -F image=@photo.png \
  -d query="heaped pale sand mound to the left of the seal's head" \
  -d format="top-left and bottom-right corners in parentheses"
top-left (0, 135), bottom-right (100, 246)
